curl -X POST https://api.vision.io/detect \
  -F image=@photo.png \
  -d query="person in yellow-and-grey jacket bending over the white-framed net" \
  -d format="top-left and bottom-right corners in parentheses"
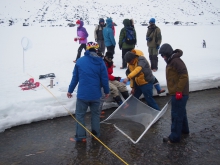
top-left (123, 49), bottom-right (160, 110)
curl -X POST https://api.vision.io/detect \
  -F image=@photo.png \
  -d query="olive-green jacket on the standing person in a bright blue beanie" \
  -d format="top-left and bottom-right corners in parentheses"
top-left (146, 24), bottom-right (162, 48)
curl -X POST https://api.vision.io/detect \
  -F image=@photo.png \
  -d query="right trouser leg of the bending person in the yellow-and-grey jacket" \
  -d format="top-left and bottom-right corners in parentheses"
top-left (140, 83), bottom-right (160, 110)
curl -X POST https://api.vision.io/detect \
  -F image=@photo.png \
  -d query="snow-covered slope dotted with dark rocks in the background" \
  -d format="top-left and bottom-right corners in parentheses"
top-left (0, 0), bottom-right (220, 27)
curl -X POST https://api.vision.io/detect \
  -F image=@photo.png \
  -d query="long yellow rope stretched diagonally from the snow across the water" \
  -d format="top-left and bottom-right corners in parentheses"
top-left (28, 74), bottom-right (128, 165)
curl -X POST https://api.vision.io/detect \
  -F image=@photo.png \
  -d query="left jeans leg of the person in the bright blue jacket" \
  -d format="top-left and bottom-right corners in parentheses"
top-left (75, 99), bottom-right (88, 140)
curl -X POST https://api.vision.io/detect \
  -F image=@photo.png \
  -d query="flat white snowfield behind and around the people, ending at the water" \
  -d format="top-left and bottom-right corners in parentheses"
top-left (0, 25), bottom-right (220, 132)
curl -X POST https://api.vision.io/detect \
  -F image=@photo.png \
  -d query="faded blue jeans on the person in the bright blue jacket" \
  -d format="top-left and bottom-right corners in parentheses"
top-left (75, 99), bottom-right (100, 139)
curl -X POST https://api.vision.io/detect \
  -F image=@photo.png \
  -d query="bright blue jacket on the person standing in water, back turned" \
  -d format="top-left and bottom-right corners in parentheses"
top-left (68, 50), bottom-right (109, 100)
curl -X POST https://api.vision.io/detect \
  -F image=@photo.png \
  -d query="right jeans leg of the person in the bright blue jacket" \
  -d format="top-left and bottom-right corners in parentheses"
top-left (90, 99), bottom-right (100, 137)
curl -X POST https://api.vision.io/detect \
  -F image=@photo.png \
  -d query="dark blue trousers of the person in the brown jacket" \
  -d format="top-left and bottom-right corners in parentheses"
top-left (169, 95), bottom-right (189, 142)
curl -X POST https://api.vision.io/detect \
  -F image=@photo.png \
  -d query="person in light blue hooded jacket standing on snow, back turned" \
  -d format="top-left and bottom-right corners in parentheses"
top-left (103, 18), bottom-right (116, 55)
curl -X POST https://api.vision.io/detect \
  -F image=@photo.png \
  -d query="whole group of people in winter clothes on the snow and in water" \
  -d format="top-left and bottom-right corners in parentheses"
top-left (67, 18), bottom-right (189, 143)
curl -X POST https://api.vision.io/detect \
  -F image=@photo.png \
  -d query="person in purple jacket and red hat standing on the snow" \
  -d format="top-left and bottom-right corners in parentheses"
top-left (73, 20), bottom-right (89, 63)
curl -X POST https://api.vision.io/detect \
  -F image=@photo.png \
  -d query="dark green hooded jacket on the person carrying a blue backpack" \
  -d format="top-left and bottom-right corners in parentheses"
top-left (118, 19), bottom-right (137, 49)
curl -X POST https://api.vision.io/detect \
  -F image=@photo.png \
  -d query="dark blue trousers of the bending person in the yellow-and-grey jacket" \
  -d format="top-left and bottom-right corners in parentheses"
top-left (134, 83), bottom-right (160, 110)
